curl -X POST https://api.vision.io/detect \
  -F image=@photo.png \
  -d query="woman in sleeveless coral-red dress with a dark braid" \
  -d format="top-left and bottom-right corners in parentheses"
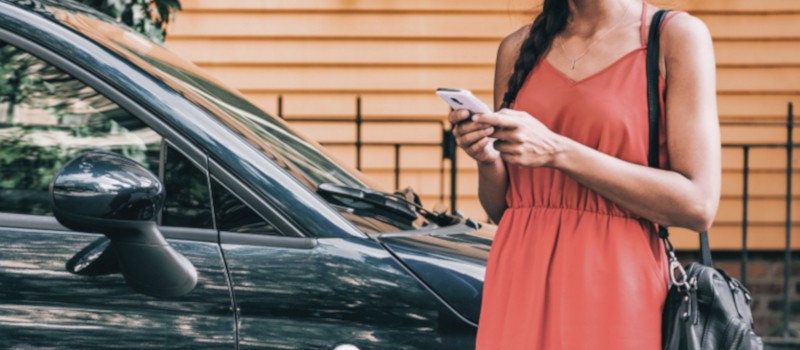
top-left (449, 0), bottom-right (720, 350)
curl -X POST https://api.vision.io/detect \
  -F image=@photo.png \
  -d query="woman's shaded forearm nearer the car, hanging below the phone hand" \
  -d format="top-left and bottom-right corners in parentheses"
top-left (478, 159), bottom-right (508, 223)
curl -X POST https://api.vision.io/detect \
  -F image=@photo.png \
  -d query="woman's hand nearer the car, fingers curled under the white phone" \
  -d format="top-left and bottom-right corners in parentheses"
top-left (447, 109), bottom-right (500, 164)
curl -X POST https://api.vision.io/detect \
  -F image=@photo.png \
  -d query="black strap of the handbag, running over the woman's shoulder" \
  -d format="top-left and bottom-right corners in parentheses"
top-left (646, 10), bottom-right (712, 266)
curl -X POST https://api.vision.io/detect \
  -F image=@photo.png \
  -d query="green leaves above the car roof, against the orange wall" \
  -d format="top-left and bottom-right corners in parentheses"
top-left (78, 0), bottom-right (181, 41)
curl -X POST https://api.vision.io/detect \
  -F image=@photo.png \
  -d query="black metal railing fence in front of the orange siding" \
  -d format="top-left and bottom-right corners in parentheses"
top-left (278, 96), bottom-right (800, 337)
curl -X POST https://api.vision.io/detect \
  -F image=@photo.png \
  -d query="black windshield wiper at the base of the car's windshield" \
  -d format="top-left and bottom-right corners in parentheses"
top-left (317, 182), bottom-right (460, 226)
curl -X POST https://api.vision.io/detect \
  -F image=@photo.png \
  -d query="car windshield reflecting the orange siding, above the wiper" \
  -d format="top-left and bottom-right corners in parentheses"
top-left (43, 6), bottom-right (434, 232)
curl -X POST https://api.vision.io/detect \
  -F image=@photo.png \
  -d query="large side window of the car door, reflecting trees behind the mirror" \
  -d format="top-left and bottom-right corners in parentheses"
top-left (0, 41), bottom-right (161, 215)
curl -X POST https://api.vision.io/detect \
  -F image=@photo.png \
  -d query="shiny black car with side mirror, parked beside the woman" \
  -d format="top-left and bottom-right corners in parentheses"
top-left (0, 0), bottom-right (494, 349)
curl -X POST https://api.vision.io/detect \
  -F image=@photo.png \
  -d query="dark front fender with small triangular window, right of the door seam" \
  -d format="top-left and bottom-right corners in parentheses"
top-left (211, 166), bottom-right (475, 350)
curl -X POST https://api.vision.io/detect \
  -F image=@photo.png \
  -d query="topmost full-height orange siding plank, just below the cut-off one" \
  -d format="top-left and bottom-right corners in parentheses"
top-left (169, 12), bottom-right (800, 40)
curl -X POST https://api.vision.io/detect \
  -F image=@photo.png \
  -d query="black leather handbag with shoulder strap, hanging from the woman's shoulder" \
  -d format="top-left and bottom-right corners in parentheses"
top-left (646, 10), bottom-right (764, 350)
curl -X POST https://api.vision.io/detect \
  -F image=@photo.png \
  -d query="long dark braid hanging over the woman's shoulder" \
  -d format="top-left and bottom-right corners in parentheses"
top-left (500, 0), bottom-right (569, 108)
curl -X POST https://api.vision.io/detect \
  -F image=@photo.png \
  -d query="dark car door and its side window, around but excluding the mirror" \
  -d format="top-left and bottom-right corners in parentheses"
top-left (0, 37), bottom-right (236, 349)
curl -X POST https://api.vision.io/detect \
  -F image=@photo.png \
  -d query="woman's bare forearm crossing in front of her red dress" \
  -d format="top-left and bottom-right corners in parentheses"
top-left (553, 138), bottom-right (719, 231)
